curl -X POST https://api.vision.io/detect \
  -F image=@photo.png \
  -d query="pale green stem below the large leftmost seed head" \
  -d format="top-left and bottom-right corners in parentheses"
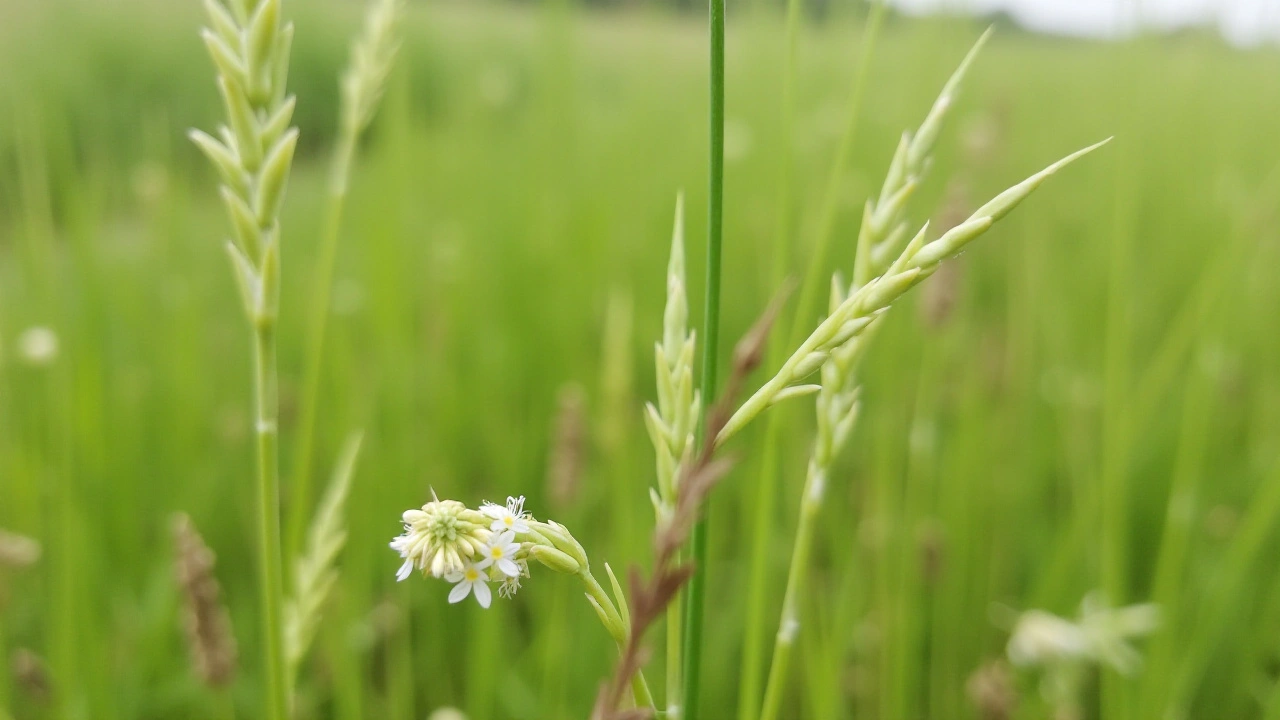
top-left (253, 318), bottom-right (287, 720)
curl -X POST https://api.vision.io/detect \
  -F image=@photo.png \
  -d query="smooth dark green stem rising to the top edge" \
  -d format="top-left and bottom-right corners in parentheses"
top-left (681, 0), bottom-right (724, 720)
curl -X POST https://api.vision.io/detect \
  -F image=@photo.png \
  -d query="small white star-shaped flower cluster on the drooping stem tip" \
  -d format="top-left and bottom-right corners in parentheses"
top-left (390, 496), bottom-right (586, 607)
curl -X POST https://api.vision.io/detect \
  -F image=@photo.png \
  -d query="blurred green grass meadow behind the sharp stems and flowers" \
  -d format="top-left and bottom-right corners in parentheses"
top-left (0, 0), bottom-right (1280, 720)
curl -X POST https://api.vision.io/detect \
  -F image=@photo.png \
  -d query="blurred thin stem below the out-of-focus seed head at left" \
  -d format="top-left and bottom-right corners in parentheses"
top-left (287, 126), bottom-right (358, 557)
